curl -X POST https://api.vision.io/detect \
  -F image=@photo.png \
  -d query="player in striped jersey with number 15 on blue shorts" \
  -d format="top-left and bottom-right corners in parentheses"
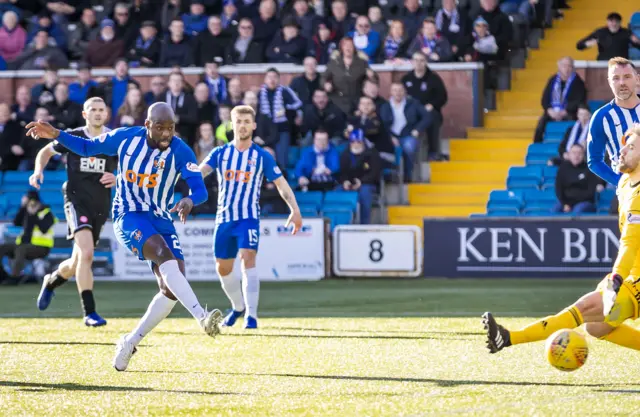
top-left (200, 106), bottom-right (302, 329)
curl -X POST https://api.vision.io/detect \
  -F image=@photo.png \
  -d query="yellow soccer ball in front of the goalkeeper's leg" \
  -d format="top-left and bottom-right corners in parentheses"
top-left (545, 329), bottom-right (589, 372)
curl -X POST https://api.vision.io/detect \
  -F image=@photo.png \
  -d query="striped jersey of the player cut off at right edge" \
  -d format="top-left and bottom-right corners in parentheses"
top-left (587, 100), bottom-right (640, 185)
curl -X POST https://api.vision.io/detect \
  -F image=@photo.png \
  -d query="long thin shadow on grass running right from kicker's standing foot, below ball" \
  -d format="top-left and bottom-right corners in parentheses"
top-left (131, 370), bottom-right (608, 386)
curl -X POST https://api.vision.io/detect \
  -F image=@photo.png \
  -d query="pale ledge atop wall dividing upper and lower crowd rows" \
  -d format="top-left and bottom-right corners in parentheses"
top-left (0, 62), bottom-right (483, 78)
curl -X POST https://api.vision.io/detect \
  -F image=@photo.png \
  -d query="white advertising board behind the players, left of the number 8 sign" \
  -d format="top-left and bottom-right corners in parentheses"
top-left (5, 219), bottom-right (325, 281)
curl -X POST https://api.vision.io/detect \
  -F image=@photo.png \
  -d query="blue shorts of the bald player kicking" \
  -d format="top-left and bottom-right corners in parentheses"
top-left (113, 211), bottom-right (184, 261)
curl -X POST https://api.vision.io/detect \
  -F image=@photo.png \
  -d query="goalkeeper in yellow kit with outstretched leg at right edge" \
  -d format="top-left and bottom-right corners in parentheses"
top-left (482, 124), bottom-right (640, 353)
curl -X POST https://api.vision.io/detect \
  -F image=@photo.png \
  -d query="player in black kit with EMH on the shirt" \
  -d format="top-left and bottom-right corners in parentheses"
top-left (29, 97), bottom-right (118, 327)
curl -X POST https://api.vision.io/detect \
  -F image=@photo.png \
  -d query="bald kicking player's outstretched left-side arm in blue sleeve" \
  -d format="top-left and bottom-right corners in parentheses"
top-left (25, 120), bottom-right (120, 156)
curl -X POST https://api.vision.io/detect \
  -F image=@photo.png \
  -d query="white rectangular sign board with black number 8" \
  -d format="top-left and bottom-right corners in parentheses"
top-left (333, 225), bottom-right (423, 277)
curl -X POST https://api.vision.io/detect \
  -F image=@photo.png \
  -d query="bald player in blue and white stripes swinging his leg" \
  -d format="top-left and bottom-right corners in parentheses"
top-left (26, 103), bottom-right (222, 371)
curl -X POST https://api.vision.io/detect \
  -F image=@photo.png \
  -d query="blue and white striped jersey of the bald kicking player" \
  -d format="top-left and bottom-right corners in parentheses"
top-left (59, 126), bottom-right (202, 220)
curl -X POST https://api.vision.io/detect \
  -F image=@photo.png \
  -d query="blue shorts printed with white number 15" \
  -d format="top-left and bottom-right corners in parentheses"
top-left (213, 219), bottom-right (260, 259)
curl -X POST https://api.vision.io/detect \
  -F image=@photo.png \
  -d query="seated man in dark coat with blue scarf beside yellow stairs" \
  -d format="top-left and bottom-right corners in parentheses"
top-left (534, 57), bottom-right (587, 142)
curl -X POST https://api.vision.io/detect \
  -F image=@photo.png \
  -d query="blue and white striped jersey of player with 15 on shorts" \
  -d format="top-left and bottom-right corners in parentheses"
top-left (205, 142), bottom-right (282, 223)
